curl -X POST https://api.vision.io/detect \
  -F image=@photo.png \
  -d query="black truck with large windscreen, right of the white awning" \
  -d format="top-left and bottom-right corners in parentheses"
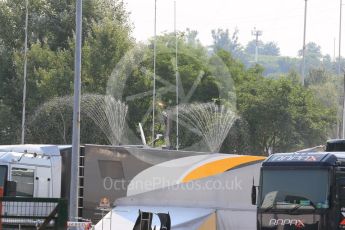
top-left (251, 140), bottom-right (345, 230)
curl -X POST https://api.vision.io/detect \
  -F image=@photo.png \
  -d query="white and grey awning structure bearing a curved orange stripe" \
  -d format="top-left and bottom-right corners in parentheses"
top-left (96, 154), bottom-right (261, 230)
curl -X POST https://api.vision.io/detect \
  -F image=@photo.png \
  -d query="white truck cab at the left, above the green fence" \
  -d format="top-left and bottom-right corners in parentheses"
top-left (0, 145), bottom-right (61, 198)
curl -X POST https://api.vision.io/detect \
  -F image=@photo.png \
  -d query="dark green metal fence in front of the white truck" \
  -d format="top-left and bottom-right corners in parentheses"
top-left (0, 197), bottom-right (68, 229)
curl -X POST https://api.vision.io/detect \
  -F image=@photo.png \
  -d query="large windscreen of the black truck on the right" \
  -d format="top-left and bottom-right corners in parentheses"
top-left (261, 169), bottom-right (330, 209)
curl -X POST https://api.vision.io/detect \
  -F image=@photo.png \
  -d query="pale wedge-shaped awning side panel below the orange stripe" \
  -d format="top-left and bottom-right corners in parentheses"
top-left (115, 163), bottom-right (260, 211)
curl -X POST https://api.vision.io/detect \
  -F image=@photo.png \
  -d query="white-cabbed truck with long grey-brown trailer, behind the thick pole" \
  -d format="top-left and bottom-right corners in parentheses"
top-left (0, 144), bottom-right (207, 225)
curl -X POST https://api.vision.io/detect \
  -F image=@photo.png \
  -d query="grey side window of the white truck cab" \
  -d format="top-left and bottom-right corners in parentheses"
top-left (11, 167), bottom-right (34, 197)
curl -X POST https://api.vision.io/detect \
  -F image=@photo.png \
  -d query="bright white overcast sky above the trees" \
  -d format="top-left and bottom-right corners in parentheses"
top-left (124, 0), bottom-right (338, 58)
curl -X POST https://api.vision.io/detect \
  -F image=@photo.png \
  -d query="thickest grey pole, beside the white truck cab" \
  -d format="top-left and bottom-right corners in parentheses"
top-left (69, 0), bottom-right (83, 221)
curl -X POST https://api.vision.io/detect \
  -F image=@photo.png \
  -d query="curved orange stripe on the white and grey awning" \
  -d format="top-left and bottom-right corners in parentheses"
top-left (182, 156), bottom-right (265, 182)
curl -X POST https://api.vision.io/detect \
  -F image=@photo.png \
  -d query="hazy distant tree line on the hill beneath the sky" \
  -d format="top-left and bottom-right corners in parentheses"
top-left (212, 29), bottom-right (345, 77)
